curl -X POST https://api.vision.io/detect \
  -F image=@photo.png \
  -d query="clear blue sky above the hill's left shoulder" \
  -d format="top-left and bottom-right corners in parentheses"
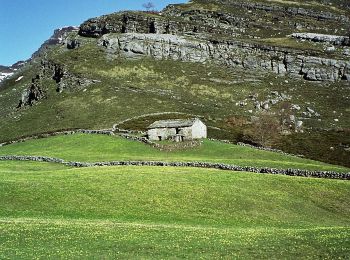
top-left (0, 0), bottom-right (187, 65)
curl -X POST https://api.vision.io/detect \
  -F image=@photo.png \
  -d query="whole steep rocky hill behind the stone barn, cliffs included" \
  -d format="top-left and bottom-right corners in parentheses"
top-left (0, 0), bottom-right (350, 166)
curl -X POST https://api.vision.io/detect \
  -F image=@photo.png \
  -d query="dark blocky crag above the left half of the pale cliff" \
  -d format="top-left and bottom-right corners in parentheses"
top-left (79, 11), bottom-right (241, 38)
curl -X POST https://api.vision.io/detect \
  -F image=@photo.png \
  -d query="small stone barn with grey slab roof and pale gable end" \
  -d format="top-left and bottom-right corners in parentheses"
top-left (147, 118), bottom-right (207, 142)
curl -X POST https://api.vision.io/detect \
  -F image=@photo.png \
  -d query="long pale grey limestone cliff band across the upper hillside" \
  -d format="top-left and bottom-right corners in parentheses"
top-left (100, 33), bottom-right (350, 81)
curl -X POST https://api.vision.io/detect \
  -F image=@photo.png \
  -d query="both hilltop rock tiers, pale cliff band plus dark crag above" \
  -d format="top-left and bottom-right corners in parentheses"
top-left (79, 0), bottom-right (350, 81)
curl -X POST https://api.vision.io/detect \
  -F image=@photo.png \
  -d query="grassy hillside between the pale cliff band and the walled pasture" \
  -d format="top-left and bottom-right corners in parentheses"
top-left (0, 37), bottom-right (350, 166)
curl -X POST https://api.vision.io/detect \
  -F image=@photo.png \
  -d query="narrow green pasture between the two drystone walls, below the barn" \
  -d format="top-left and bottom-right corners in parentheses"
top-left (0, 134), bottom-right (350, 172)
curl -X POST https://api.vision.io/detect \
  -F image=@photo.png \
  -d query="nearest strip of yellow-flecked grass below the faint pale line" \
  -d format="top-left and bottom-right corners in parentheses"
top-left (0, 219), bottom-right (350, 259)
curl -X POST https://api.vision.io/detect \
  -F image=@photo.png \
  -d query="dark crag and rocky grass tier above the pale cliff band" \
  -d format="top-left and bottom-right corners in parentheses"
top-left (79, 0), bottom-right (350, 37)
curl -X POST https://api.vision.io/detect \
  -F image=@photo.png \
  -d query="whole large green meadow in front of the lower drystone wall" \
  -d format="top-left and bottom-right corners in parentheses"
top-left (0, 162), bottom-right (350, 259)
